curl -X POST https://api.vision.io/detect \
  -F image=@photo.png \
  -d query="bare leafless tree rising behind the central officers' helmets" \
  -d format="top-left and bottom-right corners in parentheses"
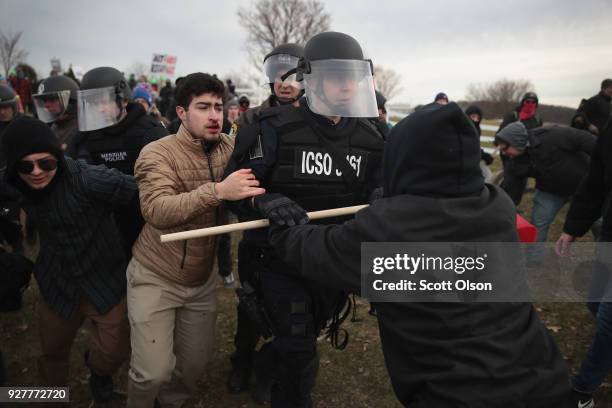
top-left (237, 0), bottom-right (331, 70)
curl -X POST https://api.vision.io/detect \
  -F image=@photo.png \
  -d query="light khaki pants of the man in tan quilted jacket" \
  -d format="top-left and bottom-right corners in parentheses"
top-left (127, 258), bottom-right (217, 408)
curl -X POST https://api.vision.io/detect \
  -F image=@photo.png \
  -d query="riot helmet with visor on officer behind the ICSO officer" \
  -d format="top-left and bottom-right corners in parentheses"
top-left (263, 44), bottom-right (304, 105)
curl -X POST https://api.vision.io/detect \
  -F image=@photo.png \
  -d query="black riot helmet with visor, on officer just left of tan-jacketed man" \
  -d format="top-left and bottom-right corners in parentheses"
top-left (78, 67), bottom-right (132, 131)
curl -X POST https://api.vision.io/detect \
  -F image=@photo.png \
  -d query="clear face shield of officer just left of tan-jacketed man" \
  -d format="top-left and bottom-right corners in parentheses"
top-left (77, 86), bottom-right (123, 132)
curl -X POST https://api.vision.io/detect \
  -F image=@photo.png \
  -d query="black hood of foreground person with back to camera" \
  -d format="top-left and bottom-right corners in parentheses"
top-left (383, 102), bottom-right (484, 198)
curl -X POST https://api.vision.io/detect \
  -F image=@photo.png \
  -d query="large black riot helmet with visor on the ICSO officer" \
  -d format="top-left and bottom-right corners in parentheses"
top-left (297, 32), bottom-right (378, 118)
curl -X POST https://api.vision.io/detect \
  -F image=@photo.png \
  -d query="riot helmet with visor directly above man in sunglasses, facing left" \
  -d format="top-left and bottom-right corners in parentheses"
top-left (32, 75), bottom-right (79, 123)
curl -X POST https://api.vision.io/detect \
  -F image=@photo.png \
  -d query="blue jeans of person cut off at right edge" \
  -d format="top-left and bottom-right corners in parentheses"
top-left (572, 303), bottom-right (612, 394)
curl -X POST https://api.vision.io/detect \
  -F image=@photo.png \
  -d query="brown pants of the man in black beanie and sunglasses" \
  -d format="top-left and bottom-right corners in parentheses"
top-left (37, 297), bottom-right (130, 386)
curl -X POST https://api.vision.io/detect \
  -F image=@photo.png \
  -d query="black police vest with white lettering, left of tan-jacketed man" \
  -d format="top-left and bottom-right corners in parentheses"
top-left (87, 131), bottom-right (145, 175)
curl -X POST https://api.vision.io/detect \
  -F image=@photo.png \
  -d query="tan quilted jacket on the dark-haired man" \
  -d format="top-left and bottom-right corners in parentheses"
top-left (133, 126), bottom-right (234, 286)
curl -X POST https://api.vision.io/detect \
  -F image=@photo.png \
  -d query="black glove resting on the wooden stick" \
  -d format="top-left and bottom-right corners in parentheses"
top-left (253, 193), bottom-right (309, 227)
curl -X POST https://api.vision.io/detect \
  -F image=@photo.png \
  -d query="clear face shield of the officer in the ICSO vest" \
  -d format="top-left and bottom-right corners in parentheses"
top-left (304, 60), bottom-right (378, 118)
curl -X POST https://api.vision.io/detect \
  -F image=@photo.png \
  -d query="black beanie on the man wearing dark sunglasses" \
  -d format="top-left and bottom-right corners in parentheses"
top-left (2, 116), bottom-right (64, 180)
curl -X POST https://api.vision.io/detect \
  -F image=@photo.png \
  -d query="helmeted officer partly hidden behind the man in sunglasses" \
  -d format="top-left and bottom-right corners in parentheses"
top-left (32, 75), bottom-right (79, 149)
